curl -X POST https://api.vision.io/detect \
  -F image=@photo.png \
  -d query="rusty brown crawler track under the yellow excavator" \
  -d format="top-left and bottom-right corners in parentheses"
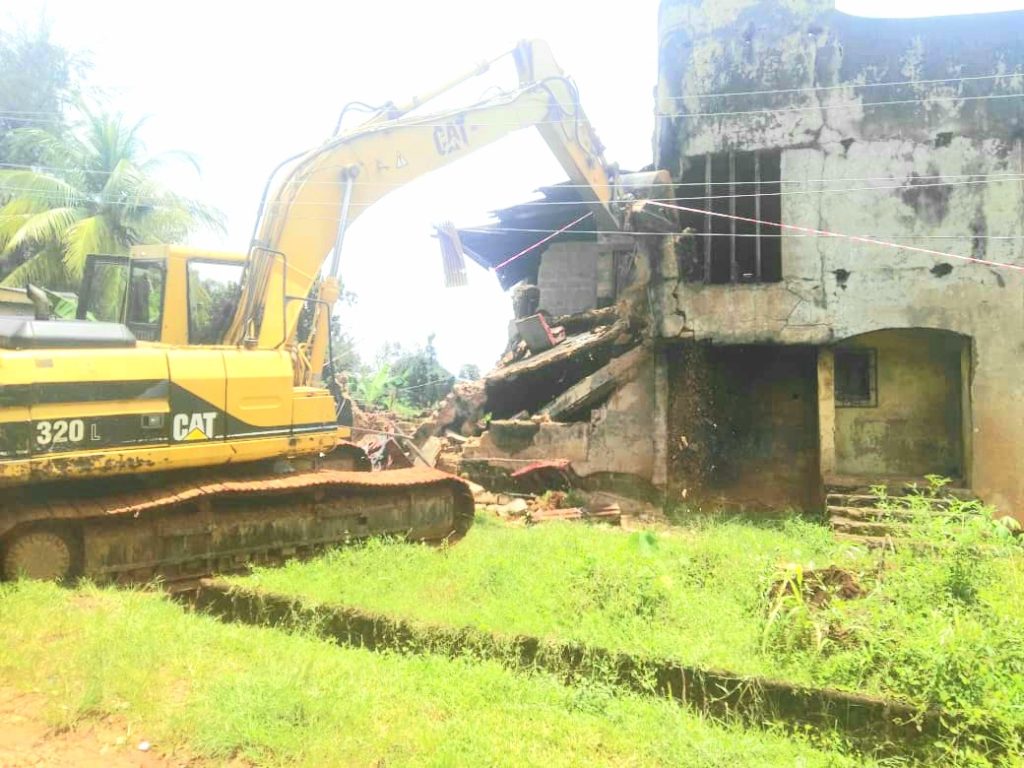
top-left (0, 467), bottom-right (473, 585)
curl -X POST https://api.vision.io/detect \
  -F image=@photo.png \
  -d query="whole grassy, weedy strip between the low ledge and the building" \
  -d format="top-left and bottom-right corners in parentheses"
top-left (236, 510), bottom-right (1024, 764)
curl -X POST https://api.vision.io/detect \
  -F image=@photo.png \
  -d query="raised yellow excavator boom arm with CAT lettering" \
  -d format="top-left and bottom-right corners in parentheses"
top-left (225, 41), bottom-right (618, 348)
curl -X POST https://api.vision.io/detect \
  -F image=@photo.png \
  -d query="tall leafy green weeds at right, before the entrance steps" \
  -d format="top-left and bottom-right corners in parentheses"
top-left (764, 477), bottom-right (1024, 765)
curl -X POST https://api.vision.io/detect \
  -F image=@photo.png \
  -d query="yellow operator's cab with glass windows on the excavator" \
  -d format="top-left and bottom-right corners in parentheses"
top-left (77, 246), bottom-right (245, 346)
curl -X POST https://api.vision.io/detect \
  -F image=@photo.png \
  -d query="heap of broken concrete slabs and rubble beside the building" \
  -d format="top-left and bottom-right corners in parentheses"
top-left (344, 302), bottom-right (651, 522)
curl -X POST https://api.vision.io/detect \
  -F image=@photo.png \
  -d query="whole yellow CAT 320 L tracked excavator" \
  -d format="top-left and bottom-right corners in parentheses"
top-left (0, 41), bottom-right (655, 583)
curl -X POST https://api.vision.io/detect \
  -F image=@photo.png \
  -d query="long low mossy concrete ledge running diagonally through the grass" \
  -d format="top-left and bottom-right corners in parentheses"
top-left (195, 580), bottom-right (998, 754)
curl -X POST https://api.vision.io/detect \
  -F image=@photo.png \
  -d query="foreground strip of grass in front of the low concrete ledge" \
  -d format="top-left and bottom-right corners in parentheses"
top-left (0, 581), bottom-right (864, 767)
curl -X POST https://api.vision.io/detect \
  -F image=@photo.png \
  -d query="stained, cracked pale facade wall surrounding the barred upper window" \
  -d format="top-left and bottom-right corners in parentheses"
top-left (655, 0), bottom-right (1024, 515)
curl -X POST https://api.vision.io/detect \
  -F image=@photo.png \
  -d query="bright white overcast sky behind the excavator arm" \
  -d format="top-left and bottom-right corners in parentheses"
top-left (0, 0), bottom-right (1024, 371)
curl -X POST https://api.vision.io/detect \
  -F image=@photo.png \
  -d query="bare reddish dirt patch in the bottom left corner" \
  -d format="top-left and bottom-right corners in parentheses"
top-left (0, 686), bottom-right (218, 768)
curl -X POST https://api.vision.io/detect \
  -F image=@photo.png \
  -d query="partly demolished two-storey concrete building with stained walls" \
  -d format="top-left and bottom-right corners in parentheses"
top-left (452, 0), bottom-right (1024, 517)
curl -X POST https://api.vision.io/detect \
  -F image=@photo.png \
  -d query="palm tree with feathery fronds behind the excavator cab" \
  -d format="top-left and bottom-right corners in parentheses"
top-left (0, 111), bottom-right (223, 290)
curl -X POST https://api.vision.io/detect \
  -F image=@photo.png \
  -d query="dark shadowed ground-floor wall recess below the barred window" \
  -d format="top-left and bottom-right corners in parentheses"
top-left (669, 343), bottom-right (819, 509)
